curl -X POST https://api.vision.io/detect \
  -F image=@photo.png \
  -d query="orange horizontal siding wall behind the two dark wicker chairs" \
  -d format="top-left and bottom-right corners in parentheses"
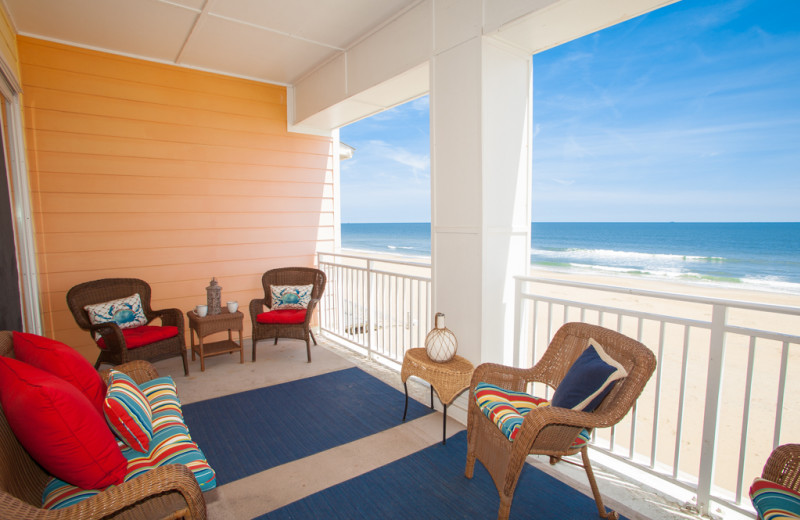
top-left (18, 37), bottom-right (334, 360)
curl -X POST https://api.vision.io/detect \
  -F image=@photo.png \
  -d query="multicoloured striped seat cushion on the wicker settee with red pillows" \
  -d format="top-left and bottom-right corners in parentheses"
top-left (42, 377), bottom-right (217, 509)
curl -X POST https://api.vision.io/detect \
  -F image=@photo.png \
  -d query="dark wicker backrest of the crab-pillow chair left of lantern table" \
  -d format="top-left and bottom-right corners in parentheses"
top-left (67, 278), bottom-right (153, 330)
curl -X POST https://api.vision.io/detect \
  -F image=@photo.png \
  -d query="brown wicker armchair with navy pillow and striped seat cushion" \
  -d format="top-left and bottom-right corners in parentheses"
top-left (465, 323), bottom-right (656, 519)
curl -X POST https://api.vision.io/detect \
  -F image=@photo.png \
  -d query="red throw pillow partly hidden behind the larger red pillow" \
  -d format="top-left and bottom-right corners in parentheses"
top-left (14, 332), bottom-right (106, 415)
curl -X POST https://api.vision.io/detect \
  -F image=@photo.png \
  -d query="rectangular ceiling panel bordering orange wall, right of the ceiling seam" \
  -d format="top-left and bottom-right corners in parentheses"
top-left (181, 16), bottom-right (337, 84)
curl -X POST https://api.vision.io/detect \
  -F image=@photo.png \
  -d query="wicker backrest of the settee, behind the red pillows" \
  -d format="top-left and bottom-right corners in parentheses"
top-left (0, 330), bottom-right (50, 507)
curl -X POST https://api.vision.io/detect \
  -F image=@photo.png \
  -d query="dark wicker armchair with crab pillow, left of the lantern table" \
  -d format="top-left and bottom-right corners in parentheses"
top-left (67, 278), bottom-right (189, 376)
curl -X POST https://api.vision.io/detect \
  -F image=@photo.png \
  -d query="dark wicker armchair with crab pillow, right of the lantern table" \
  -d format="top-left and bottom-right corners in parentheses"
top-left (250, 267), bottom-right (326, 363)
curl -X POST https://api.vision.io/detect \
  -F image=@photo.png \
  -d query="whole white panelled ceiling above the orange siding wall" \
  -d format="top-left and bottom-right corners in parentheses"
top-left (2, 0), bottom-right (419, 85)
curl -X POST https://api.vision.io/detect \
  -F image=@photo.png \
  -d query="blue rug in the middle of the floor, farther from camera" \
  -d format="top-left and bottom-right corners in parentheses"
top-left (183, 368), bottom-right (431, 486)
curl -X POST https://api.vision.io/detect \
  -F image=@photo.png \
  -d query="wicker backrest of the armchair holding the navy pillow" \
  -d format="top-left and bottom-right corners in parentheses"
top-left (536, 323), bottom-right (656, 422)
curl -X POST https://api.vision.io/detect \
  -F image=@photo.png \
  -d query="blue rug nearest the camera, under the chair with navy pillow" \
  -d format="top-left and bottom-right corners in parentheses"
top-left (258, 431), bottom-right (624, 520)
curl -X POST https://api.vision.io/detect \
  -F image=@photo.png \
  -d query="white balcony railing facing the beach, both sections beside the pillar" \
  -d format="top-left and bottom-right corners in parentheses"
top-left (319, 254), bottom-right (800, 513)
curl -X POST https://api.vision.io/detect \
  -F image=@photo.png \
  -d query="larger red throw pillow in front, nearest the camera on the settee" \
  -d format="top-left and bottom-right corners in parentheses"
top-left (0, 357), bottom-right (127, 489)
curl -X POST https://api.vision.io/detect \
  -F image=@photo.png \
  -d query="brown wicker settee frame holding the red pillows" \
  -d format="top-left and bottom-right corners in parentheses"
top-left (0, 331), bottom-right (206, 520)
